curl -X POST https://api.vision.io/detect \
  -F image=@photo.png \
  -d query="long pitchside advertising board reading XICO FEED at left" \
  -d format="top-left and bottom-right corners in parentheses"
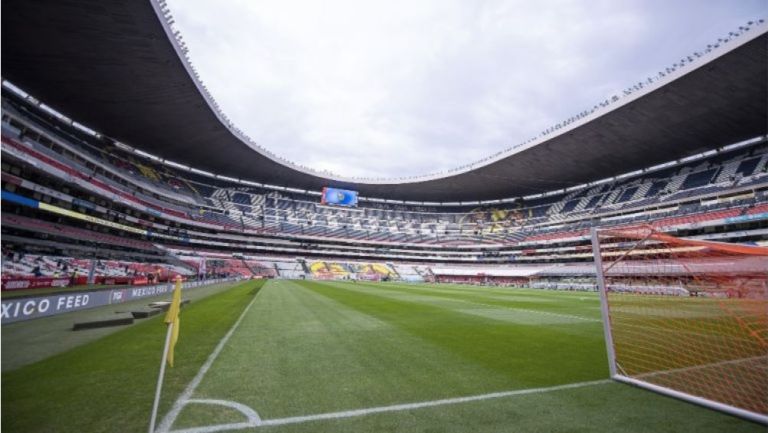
top-left (0, 278), bottom-right (239, 325)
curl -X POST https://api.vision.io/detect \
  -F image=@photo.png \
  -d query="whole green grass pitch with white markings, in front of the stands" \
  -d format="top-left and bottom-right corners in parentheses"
top-left (2, 280), bottom-right (765, 433)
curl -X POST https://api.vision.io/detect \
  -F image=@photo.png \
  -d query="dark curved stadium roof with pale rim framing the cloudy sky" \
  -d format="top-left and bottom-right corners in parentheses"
top-left (2, 0), bottom-right (768, 202)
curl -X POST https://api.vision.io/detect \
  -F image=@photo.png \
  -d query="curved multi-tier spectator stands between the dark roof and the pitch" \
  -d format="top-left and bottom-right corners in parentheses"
top-left (2, 43), bottom-right (768, 289)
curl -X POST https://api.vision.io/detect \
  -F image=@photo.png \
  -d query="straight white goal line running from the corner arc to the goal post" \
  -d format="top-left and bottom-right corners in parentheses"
top-left (170, 379), bottom-right (611, 433)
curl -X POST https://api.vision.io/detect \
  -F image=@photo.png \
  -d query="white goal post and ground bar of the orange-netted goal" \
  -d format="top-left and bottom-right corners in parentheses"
top-left (591, 227), bottom-right (768, 425)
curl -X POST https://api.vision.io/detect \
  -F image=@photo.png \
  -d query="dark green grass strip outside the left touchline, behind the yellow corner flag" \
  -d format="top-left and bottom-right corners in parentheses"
top-left (2, 282), bottom-right (262, 432)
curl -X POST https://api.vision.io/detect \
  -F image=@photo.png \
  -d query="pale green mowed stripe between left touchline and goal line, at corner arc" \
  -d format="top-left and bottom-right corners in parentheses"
top-left (174, 281), bottom-right (511, 422)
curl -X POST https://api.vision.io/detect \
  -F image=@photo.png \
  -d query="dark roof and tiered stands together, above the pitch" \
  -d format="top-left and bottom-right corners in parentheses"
top-left (2, 1), bottom-right (768, 289)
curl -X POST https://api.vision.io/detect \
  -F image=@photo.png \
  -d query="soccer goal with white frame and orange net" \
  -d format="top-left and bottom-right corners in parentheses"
top-left (592, 226), bottom-right (768, 424)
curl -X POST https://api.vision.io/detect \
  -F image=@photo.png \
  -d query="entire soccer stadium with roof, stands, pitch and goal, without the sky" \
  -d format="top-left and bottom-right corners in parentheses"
top-left (2, 0), bottom-right (768, 433)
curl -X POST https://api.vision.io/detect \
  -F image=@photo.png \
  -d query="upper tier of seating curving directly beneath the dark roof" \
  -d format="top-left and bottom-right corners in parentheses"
top-left (2, 93), bottom-right (768, 253)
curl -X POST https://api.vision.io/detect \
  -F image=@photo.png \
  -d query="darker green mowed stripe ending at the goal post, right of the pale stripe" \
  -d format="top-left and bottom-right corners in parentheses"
top-left (300, 282), bottom-right (607, 387)
